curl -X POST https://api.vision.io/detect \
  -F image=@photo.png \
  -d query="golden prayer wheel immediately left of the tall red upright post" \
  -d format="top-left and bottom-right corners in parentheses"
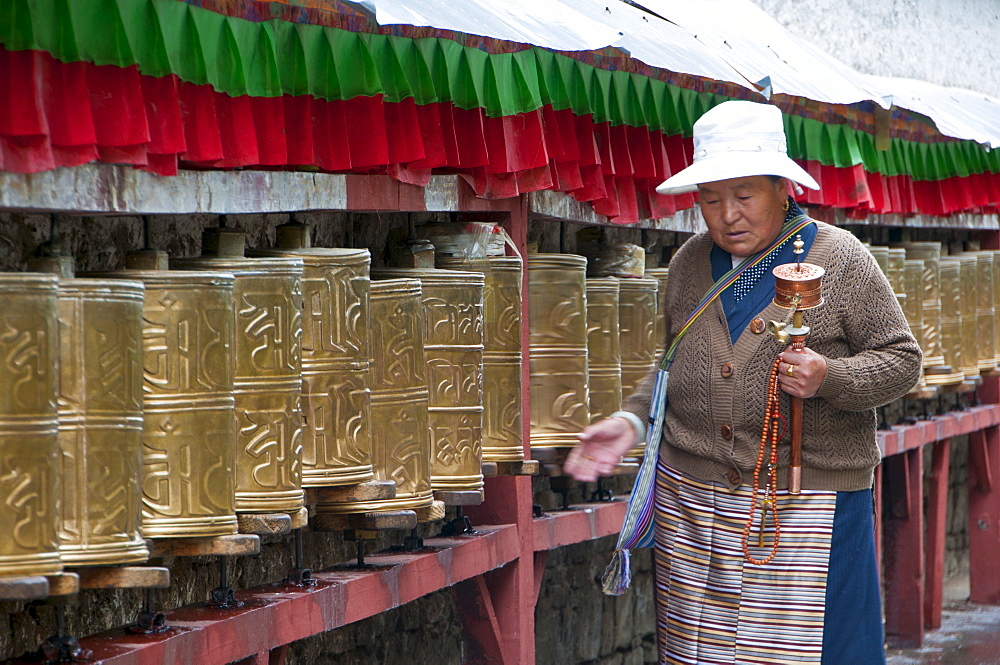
top-left (437, 256), bottom-right (524, 462)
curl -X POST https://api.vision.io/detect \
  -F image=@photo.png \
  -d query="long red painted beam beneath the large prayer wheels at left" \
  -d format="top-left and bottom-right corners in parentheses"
top-left (28, 525), bottom-right (530, 665)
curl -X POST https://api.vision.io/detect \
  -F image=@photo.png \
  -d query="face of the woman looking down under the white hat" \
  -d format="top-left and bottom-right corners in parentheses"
top-left (698, 175), bottom-right (788, 258)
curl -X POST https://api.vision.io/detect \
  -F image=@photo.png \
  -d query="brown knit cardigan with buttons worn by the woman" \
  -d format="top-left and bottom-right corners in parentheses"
top-left (623, 222), bottom-right (921, 491)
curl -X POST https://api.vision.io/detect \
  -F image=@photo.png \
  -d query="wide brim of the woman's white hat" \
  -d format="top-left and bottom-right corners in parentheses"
top-left (656, 152), bottom-right (819, 194)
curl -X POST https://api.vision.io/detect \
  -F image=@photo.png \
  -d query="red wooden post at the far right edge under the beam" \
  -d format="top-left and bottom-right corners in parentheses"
top-left (968, 426), bottom-right (1000, 605)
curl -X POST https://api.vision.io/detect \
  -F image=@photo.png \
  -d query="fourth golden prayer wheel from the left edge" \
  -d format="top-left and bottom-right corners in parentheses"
top-left (171, 229), bottom-right (304, 513)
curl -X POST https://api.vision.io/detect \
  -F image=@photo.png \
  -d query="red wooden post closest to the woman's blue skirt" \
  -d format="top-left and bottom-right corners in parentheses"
top-left (883, 448), bottom-right (924, 648)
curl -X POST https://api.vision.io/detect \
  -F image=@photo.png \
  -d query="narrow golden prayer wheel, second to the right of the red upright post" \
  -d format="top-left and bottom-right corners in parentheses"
top-left (587, 277), bottom-right (622, 422)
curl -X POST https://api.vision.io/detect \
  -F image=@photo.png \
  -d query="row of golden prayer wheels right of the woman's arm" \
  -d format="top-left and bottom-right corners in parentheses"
top-left (869, 242), bottom-right (1000, 386)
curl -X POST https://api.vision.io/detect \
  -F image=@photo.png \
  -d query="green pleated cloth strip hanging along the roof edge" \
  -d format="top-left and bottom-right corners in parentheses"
top-left (0, 0), bottom-right (1000, 180)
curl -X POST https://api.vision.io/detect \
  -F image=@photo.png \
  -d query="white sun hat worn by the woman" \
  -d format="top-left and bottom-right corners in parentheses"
top-left (656, 100), bottom-right (819, 194)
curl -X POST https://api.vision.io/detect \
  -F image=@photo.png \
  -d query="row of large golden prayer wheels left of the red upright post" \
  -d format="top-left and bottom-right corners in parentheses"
top-left (0, 230), bottom-right (523, 576)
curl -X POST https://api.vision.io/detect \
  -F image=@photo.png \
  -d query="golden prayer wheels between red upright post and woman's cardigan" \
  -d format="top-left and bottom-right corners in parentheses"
top-left (528, 254), bottom-right (665, 464)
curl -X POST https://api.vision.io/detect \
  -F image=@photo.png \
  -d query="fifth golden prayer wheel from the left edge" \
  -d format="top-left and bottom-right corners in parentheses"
top-left (252, 247), bottom-right (375, 487)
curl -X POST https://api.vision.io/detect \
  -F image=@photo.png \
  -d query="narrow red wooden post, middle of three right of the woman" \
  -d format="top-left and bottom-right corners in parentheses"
top-left (924, 439), bottom-right (951, 629)
